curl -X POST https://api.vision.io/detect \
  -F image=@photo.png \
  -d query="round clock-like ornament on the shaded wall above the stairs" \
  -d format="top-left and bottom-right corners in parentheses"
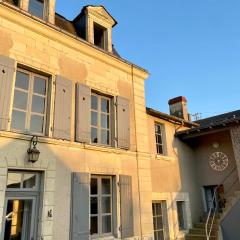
top-left (209, 152), bottom-right (228, 172)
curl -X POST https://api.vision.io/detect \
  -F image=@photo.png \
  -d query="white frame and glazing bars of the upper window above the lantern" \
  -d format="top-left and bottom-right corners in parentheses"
top-left (10, 68), bottom-right (49, 136)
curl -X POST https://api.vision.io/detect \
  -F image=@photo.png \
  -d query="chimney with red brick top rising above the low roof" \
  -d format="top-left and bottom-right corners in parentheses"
top-left (168, 96), bottom-right (190, 121)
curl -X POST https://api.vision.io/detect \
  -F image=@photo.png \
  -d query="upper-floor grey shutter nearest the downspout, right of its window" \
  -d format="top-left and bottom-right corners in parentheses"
top-left (117, 96), bottom-right (130, 149)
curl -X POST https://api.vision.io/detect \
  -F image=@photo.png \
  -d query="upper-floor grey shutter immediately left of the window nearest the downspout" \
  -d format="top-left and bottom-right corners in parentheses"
top-left (76, 83), bottom-right (91, 143)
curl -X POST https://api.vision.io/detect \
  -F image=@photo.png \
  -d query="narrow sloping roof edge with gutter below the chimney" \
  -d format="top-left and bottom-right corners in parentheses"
top-left (146, 107), bottom-right (198, 127)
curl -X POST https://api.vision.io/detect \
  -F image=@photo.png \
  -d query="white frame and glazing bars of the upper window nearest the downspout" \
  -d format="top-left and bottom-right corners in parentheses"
top-left (90, 92), bottom-right (112, 146)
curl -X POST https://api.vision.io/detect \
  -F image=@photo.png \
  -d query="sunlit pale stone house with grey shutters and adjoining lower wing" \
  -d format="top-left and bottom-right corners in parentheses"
top-left (0, 0), bottom-right (240, 240)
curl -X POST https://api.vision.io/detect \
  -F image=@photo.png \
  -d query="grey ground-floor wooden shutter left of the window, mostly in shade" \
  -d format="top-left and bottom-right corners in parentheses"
top-left (70, 173), bottom-right (90, 240)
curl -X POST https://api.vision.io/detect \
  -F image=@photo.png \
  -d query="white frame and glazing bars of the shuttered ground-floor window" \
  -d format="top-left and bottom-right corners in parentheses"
top-left (90, 175), bottom-right (114, 239)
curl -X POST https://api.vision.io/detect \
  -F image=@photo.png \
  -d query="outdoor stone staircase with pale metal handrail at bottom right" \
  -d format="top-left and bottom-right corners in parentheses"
top-left (185, 191), bottom-right (240, 240)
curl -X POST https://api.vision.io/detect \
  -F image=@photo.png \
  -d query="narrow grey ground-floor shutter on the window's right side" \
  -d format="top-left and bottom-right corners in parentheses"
top-left (119, 175), bottom-right (134, 238)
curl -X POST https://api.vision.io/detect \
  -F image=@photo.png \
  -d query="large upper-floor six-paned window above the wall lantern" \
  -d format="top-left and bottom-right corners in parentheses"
top-left (11, 69), bottom-right (48, 135)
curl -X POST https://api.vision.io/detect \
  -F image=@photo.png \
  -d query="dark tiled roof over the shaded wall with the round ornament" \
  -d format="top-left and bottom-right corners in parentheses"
top-left (176, 110), bottom-right (240, 138)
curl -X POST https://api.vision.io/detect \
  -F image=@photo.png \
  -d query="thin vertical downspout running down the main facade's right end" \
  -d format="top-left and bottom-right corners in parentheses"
top-left (131, 64), bottom-right (143, 239)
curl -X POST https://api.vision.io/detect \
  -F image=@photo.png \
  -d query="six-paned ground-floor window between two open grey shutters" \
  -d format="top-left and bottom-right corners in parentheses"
top-left (90, 176), bottom-right (112, 238)
